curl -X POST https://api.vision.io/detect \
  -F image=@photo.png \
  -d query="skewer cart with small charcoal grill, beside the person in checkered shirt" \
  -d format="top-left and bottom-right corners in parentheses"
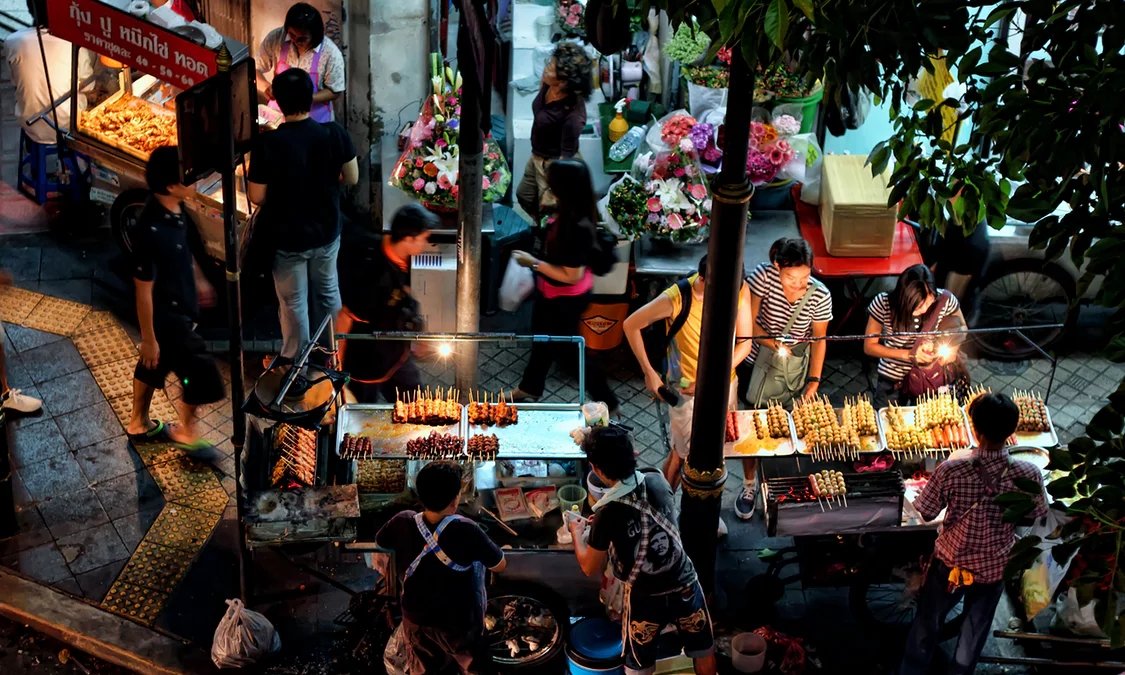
top-left (725, 392), bottom-right (1059, 637)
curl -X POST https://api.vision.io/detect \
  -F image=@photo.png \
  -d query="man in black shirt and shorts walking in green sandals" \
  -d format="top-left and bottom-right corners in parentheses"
top-left (125, 146), bottom-right (225, 457)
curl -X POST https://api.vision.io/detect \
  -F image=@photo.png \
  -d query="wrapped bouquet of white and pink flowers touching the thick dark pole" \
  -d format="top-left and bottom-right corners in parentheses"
top-left (645, 135), bottom-right (711, 242)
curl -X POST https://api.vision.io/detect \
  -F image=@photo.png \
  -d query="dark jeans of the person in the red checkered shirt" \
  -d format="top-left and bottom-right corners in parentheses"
top-left (899, 558), bottom-right (1004, 675)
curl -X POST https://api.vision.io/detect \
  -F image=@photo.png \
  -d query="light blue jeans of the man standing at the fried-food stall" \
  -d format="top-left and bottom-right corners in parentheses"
top-left (273, 237), bottom-right (341, 359)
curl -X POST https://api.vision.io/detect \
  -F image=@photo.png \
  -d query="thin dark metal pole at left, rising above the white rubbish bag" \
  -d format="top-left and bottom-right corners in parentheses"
top-left (217, 44), bottom-right (249, 601)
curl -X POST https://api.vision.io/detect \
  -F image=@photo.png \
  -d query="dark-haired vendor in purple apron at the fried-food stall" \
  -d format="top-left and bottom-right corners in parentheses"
top-left (257, 2), bottom-right (347, 123)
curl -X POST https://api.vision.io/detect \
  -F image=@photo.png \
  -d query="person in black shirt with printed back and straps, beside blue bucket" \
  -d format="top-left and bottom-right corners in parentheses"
top-left (567, 425), bottom-right (716, 675)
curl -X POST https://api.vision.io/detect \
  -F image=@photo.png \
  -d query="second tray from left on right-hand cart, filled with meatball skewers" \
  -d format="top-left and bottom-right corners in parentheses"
top-left (793, 396), bottom-right (887, 460)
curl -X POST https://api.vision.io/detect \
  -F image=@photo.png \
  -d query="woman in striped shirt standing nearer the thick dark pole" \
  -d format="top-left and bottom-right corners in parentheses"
top-left (735, 237), bottom-right (833, 520)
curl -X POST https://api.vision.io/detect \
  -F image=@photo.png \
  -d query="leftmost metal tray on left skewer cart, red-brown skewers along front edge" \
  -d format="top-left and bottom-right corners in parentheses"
top-left (336, 403), bottom-right (465, 459)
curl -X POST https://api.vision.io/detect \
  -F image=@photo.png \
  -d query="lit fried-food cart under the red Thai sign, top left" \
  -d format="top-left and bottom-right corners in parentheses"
top-left (47, 0), bottom-right (254, 260)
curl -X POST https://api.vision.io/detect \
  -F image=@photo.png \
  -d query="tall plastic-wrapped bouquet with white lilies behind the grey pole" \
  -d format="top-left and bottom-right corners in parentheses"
top-left (389, 54), bottom-right (512, 210)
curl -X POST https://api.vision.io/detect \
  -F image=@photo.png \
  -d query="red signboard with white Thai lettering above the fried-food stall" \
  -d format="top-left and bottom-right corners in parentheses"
top-left (47, 0), bottom-right (218, 89)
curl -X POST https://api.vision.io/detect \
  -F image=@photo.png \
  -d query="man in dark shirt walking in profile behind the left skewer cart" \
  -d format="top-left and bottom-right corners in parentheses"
top-left (336, 204), bottom-right (440, 403)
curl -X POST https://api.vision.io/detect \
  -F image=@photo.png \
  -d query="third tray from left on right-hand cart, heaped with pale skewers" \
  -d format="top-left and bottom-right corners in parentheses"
top-left (879, 394), bottom-right (973, 457)
